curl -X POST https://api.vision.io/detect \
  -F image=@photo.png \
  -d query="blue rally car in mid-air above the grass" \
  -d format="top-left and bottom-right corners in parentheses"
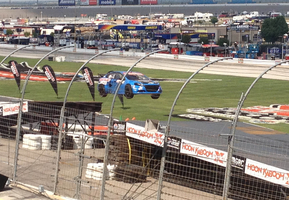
top-left (97, 71), bottom-right (162, 99)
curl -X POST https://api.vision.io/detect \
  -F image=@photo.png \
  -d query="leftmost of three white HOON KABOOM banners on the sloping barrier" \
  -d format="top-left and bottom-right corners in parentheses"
top-left (126, 123), bottom-right (164, 147)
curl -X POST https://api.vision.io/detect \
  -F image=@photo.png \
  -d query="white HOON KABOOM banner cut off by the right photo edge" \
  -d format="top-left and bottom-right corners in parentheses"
top-left (245, 159), bottom-right (289, 188)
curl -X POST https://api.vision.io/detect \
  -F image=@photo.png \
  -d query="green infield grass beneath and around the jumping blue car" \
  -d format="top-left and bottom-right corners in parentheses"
top-left (0, 55), bottom-right (289, 132)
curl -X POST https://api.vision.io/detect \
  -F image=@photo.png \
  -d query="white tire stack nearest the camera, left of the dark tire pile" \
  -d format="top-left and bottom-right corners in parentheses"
top-left (85, 163), bottom-right (115, 180)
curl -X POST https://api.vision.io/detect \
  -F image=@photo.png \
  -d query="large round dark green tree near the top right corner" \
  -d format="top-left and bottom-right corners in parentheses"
top-left (261, 16), bottom-right (288, 43)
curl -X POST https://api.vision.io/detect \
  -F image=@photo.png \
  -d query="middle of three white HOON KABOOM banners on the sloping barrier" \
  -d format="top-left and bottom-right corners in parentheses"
top-left (180, 140), bottom-right (227, 167)
